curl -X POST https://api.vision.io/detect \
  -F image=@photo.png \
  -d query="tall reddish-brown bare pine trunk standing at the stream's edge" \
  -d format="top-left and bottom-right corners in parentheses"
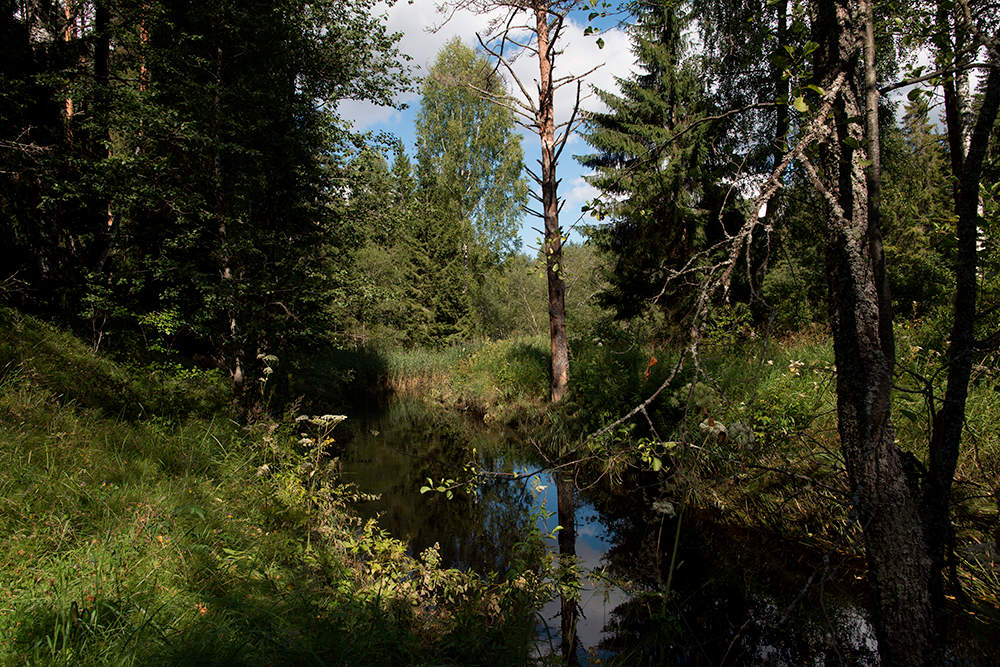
top-left (534, 2), bottom-right (569, 403)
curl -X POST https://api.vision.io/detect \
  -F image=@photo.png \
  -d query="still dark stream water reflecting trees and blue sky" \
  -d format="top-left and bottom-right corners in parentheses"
top-left (340, 401), bottom-right (878, 665)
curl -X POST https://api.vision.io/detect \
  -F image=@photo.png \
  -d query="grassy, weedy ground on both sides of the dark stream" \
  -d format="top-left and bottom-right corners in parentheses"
top-left (0, 309), bottom-right (1000, 665)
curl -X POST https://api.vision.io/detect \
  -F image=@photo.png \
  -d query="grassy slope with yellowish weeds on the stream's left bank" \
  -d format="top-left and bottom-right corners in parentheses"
top-left (0, 310), bottom-right (541, 665)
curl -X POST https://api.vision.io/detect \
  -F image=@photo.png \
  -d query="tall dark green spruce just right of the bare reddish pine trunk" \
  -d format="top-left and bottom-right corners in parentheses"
top-left (578, 0), bottom-right (718, 324)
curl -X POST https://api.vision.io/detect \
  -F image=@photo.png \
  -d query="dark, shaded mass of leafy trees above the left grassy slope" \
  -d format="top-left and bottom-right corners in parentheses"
top-left (0, 0), bottom-right (405, 404)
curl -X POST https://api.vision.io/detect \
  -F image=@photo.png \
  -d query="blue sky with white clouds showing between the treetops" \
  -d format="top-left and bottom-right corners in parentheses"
top-left (338, 0), bottom-right (636, 251)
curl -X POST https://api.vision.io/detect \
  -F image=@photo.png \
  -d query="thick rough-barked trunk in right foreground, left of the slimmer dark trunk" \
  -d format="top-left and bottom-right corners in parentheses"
top-left (814, 0), bottom-right (936, 665)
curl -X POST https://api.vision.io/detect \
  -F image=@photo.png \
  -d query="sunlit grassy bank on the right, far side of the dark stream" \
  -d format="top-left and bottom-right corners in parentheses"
top-left (370, 325), bottom-right (1000, 616)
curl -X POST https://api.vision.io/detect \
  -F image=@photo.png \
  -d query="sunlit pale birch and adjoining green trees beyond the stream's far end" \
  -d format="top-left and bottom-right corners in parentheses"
top-left (344, 39), bottom-right (527, 348)
